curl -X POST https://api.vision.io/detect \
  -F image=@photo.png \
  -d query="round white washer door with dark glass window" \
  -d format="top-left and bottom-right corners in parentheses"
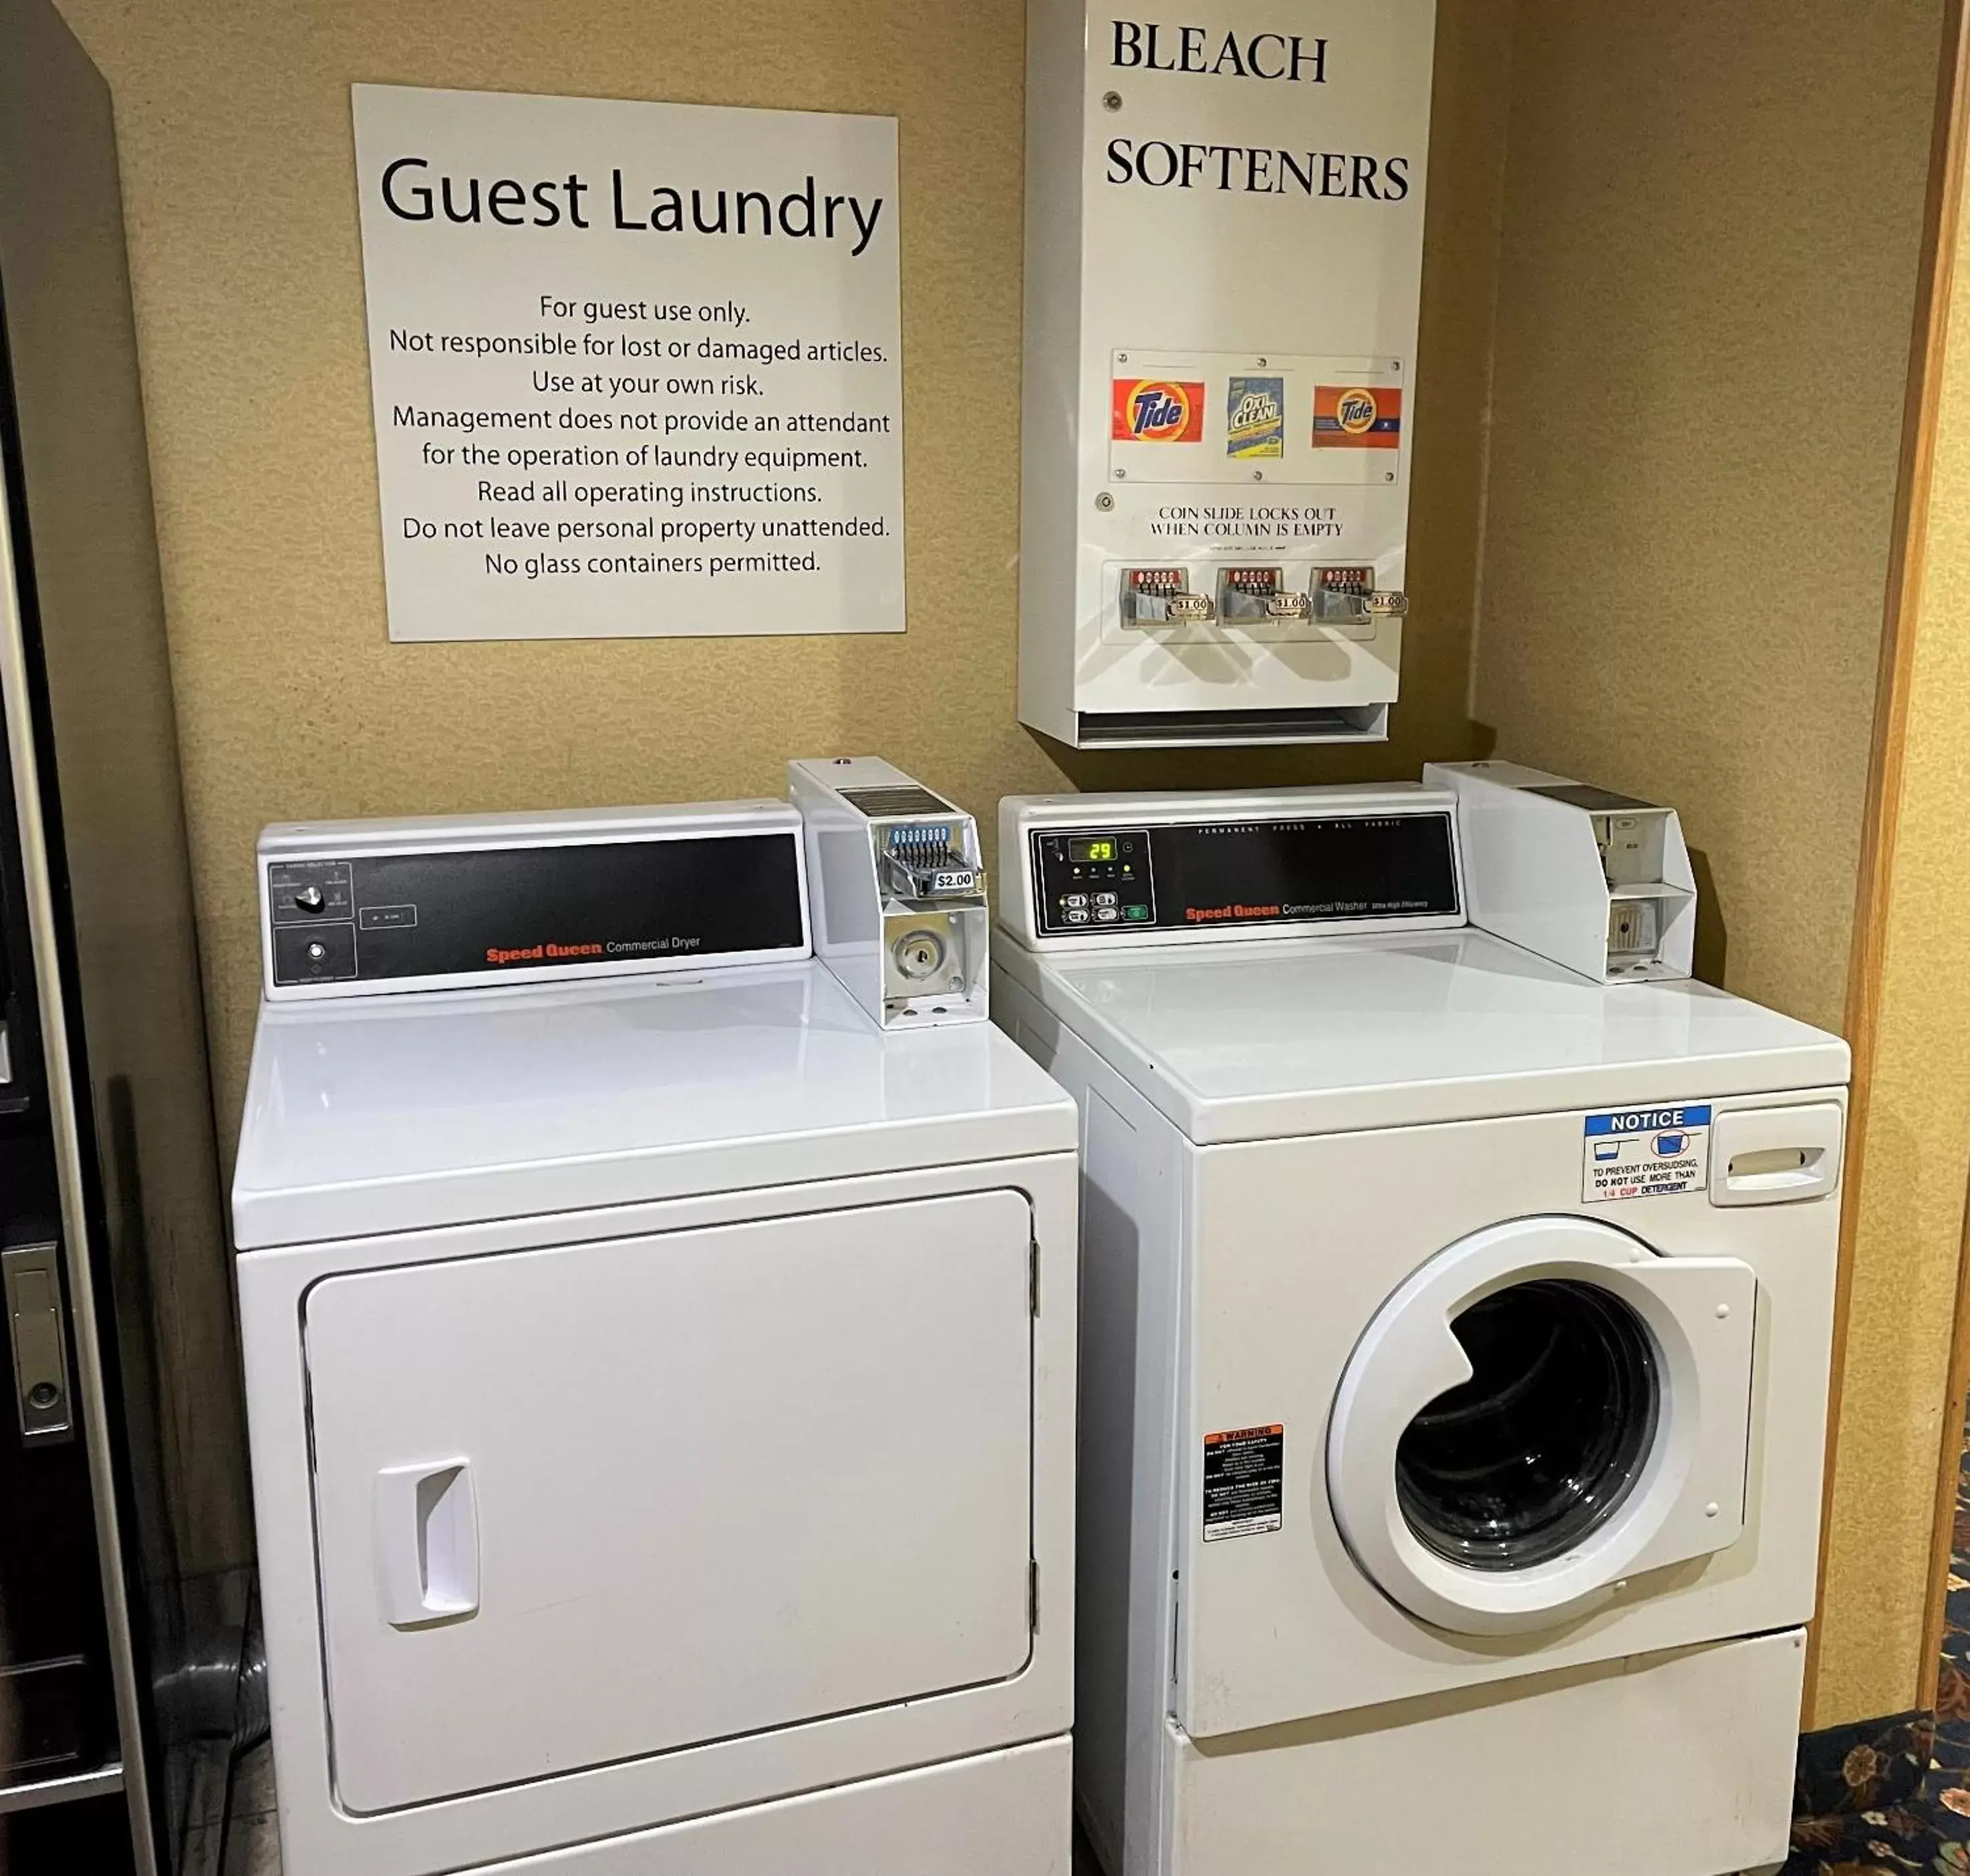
top-left (1328, 1217), bottom-right (1757, 1634)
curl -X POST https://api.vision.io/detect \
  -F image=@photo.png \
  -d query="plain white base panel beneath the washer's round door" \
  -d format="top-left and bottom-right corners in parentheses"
top-left (1158, 1630), bottom-right (1806, 1876)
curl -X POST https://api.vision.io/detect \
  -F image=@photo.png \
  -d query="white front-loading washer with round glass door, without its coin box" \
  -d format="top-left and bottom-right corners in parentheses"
top-left (991, 788), bottom-right (1848, 1876)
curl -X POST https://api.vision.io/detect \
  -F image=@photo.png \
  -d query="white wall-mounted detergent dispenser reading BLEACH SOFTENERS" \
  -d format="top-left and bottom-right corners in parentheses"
top-left (1018, 0), bottom-right (1436, 748)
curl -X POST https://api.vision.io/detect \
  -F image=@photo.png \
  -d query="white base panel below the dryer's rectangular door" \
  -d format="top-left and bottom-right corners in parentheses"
top-left (480, 1738), bottom-right (1074, 1876)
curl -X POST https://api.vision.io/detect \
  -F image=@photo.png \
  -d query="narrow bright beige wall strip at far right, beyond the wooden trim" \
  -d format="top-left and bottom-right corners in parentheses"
top-left (1814, 146), bottom-right (1970, 1724)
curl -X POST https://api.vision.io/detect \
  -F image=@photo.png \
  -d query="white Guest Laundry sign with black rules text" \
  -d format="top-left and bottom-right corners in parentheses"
top-left (353, 85), bottom-right (902, 640)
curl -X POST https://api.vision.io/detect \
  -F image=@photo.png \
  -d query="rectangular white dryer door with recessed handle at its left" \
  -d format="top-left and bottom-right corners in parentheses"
top-left (301, 1191), bottom-right (1032, 1813)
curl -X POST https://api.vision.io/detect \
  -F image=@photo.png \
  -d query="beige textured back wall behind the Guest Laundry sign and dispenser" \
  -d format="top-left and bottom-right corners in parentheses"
top-left (61, 0), bottom-right (1509, 1136)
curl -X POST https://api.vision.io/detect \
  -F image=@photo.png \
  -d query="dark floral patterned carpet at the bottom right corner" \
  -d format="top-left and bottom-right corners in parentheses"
top-left (1785, 1386), bottom-right (1970, 1876)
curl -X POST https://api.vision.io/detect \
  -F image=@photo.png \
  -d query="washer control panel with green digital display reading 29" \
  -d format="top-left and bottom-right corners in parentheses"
top-left (999, 784), bottom-right (1463, 949)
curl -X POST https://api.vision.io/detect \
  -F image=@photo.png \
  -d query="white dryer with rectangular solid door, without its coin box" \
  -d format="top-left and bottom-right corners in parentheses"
top-left (235, 801), bottom-right (1076, 1876)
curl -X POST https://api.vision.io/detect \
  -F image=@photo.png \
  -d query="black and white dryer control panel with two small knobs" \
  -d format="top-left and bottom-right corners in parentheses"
top-left (260, 801), bottom-right (810, 1002)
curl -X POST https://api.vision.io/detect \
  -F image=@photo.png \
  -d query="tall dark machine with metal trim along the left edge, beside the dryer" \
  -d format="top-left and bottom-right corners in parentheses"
top-left (0, 0), bottom-right (252, 1876)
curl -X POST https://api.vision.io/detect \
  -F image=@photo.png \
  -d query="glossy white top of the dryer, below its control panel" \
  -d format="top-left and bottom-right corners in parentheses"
top-left (233, 963), bottom-right (1078, 1250)
